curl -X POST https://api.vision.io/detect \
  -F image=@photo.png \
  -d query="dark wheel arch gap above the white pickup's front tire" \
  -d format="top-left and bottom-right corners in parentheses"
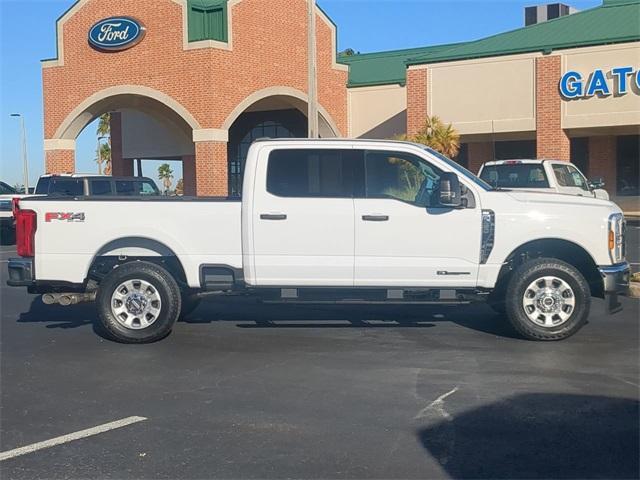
top-left (496, 237), bottom-right (604, 298)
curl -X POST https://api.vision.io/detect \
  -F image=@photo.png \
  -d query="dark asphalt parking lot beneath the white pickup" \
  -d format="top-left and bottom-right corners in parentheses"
top-left (0, 238), bottom-right (640, 479)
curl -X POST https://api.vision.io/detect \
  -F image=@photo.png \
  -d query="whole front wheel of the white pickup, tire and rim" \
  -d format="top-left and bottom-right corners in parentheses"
top-left (505, 258), bottom-right (591, 341)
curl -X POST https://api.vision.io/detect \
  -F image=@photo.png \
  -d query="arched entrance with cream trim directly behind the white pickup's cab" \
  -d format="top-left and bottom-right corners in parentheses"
top-left (224, 87), bottom-right (338, 197)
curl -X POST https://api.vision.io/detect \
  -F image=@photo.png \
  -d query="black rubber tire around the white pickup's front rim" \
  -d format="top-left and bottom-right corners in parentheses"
top-left (505, 258), bottom-right (591, 341)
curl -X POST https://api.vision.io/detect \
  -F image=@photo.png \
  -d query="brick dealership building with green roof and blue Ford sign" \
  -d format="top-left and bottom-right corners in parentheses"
top-left (43, 0), bottom-right (640, 195)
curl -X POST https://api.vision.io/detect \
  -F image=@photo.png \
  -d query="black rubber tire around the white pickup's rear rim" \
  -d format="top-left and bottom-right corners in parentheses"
top-left (96, 262), bottom-right (181, 343)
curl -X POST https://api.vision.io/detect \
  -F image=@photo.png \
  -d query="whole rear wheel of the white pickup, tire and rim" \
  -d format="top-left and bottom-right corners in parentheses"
top-left (96, 262), bottom-right (181, 343)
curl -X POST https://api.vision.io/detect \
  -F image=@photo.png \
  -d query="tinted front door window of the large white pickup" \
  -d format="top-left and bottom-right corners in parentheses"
top-left (365, 151), bottom-right (442, 207)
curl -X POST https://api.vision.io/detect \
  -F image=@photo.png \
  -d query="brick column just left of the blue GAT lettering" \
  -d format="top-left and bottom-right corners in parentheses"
top-left (536, 55), bottom-right (571, 162)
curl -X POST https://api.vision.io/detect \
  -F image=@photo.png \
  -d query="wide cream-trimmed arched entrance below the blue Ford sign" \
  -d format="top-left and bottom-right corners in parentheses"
top-left (45, 86), bottom-right (199, 194)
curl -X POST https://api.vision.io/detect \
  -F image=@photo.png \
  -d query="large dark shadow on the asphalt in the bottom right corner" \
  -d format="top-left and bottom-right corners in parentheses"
top-left (417, 393), bottom-right (640, 478)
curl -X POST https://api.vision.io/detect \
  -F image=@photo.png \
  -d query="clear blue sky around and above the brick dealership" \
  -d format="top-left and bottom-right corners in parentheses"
top-left (0, 0), bottom-right (602, 185)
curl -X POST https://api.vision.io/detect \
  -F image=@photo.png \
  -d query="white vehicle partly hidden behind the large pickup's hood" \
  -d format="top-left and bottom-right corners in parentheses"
top-left (478, 160), bottom-right (609, 200)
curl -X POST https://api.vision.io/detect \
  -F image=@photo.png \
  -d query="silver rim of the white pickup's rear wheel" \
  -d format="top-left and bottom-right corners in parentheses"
top-left (111, 279), bottom-right (162, 330)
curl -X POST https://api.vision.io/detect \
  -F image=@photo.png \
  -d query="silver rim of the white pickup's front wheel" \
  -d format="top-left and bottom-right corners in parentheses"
top-left (522, 276), bottom-right (576, 328)
